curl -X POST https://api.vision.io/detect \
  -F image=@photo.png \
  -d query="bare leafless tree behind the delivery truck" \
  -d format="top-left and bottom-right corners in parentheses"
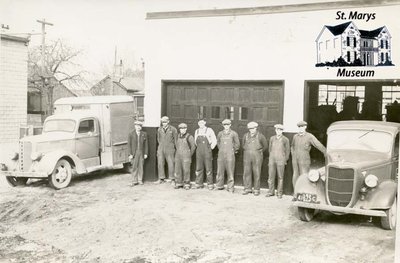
top-left (28, 39), bottom-right (87, 115)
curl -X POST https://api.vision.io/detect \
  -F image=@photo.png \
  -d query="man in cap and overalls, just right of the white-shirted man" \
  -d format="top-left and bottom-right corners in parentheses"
top-left (216, 119), bottom-right (240, 193)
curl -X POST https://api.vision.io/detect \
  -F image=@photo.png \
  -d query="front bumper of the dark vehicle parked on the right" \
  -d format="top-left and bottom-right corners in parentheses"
top-left (293, 201), bottom-right (386, 217)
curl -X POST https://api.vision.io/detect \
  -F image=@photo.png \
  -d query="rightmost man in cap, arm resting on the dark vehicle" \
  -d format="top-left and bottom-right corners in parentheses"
top-left (291, 121), bottom-right (326, 188)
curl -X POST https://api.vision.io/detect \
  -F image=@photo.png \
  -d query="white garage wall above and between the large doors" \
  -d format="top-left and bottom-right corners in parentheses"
top-left (145, 6), bottom-right (400, 131)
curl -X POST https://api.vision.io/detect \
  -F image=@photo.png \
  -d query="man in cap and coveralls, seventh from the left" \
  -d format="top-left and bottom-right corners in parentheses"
top-left (266, 124), bottom-right (290, 199)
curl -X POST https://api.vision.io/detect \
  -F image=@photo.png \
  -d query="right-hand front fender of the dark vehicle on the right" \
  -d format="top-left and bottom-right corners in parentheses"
top-left (364, 181), bottom-right (397, 210)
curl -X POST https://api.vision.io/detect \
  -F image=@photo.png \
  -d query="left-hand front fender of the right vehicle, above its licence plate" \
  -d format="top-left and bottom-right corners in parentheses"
top-left (294, 174), bottom-right (326, 204)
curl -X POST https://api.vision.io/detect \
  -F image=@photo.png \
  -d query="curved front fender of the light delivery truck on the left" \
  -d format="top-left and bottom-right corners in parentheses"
top-left (37, 150), bottom-right (86, 175)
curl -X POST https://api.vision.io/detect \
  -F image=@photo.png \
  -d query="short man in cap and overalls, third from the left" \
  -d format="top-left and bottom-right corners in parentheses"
top-left (175, 123), bottom-right (196, 190)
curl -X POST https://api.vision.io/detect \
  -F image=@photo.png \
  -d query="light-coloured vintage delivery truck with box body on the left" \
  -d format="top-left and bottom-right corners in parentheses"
top-left (0, 96), bottom-right (135, 189)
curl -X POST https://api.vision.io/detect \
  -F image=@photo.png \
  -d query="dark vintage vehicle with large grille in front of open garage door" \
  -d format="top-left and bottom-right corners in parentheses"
top-left (293, 121), bottom-right (400, 230)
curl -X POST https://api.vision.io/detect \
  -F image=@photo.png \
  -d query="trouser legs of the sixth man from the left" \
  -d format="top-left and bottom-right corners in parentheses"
top-left (243, 150), bottom-right (263, 192)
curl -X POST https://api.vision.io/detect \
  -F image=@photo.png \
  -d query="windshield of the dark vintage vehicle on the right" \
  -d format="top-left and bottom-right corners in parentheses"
top-left (328, 129), bottom-right (393, 153)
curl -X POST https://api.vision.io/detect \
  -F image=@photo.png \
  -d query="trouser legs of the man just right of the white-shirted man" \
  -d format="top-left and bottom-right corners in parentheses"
top-left (216, 152), bottom-right (235, 190)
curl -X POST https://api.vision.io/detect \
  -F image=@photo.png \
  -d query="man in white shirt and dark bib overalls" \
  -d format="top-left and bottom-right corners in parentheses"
top-left (194, 119), bottom-right (217, 190)
